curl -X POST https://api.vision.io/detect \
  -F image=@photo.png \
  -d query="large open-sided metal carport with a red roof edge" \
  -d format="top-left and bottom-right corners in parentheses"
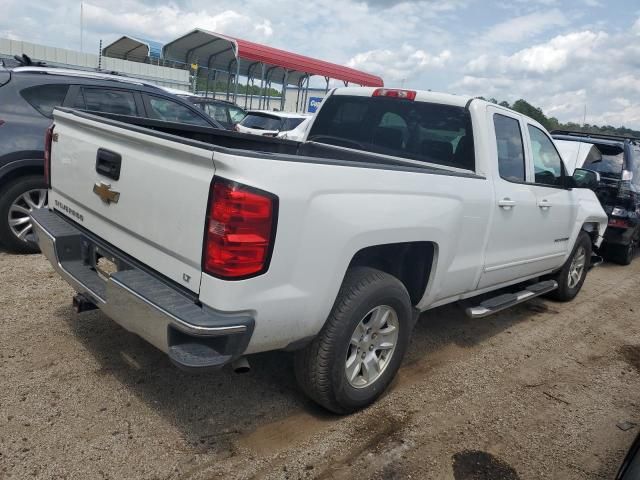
top-left (162, 28), bottom-right (384, 109)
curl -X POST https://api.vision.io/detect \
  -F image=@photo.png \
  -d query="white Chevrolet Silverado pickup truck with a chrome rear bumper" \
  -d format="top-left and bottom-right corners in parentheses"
top-left (32, 88), bottom-right (607, 413)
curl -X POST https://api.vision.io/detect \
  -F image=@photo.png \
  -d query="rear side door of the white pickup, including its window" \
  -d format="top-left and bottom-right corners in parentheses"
top-left (478, 106), bottom-right (557, 288)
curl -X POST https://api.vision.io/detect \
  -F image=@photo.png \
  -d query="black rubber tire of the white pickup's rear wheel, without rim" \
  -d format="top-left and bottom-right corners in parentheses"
top-left (295, 267), bottom-right (413, 414)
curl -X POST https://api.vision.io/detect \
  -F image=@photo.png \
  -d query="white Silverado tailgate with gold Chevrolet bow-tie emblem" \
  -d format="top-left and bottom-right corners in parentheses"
top-left (49, 110), bottom-right (215, 293)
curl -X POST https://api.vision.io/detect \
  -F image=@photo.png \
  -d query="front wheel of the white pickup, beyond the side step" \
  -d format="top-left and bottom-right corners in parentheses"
top-left (548, 232), bottom-right (591, 302)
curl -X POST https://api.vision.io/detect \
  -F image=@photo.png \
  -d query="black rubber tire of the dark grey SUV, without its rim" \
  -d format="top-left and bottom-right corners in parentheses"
top-left (0, 175), bottom-right (47, 253)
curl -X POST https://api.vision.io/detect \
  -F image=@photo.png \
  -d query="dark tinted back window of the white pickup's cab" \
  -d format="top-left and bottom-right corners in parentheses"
top-left (308, 95), bottom-right (475, 170)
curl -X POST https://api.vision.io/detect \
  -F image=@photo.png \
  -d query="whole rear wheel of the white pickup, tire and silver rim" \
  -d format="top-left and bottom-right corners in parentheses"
top-left (295, 267), bottom-right (412, 414)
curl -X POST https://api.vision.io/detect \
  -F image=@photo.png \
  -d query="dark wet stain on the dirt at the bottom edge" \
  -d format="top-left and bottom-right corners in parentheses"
top-left (453, 450), bottom-right (520, 480)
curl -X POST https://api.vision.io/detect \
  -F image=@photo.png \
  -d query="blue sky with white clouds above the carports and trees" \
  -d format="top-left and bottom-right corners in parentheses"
top-left (0, 0), bottom-right (640, 128)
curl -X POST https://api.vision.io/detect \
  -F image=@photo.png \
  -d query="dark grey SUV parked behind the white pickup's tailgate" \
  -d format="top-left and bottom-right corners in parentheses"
top-left (0, 67), bottom-right (223, 253)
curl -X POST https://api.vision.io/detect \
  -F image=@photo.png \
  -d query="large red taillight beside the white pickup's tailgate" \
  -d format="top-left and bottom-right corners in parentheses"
top-left (202, 177), bottom-right (278, 280)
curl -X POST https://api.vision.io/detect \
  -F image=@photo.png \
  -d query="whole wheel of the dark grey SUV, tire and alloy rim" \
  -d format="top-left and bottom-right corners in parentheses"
top-left (0, 175), bottom-right (47, 253)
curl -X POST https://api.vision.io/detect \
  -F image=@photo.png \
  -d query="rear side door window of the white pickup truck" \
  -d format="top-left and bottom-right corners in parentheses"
top-left (493, 113), bottom-right (525, 182)
